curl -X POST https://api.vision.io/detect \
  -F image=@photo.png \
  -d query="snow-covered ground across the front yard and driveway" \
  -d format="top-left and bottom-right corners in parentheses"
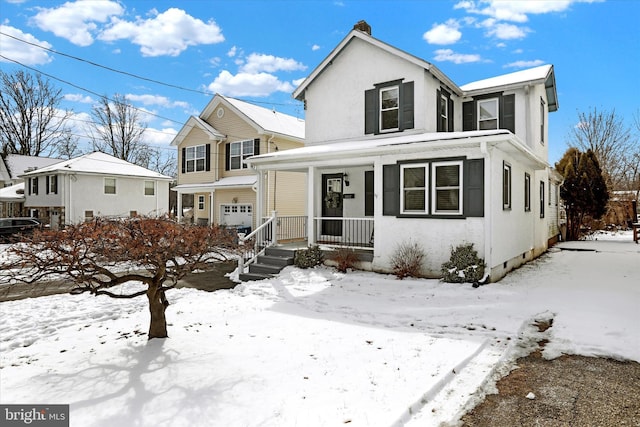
top-left (0, 232), bottom-right (640, 427)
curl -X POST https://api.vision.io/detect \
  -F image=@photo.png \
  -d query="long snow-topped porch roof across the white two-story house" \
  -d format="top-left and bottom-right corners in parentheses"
top-left (245, 129), bottom-right (547, 169)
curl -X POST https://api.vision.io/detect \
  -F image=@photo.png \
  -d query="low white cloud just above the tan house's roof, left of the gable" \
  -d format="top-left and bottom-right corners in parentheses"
top-left (207, 70), bottom-right (294, 96)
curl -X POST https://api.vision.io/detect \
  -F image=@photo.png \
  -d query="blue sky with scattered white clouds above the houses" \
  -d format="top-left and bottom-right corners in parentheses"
top-left (0, 0), bottom-right (640, 163)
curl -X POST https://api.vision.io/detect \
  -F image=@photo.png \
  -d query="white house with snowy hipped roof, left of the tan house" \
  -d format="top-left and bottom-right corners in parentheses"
top-left (21, 152), bottom-right (172, 228)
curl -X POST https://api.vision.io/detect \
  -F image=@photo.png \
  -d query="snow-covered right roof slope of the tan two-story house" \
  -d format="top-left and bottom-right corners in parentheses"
top-left (218, 95), bottom-right (304, 139)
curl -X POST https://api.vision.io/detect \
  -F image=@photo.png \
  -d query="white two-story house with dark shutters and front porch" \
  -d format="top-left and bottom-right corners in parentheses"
top-left (247, 22), bottom-right (558, 280)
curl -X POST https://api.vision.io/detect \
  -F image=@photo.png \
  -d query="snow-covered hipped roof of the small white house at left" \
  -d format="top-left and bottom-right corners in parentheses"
top-left (24, 151), bottom-right (172, 179)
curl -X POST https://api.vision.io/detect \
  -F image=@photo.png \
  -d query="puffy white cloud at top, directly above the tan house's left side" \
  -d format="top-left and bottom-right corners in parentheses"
top-left (98, 8), bottom-right (224, 56)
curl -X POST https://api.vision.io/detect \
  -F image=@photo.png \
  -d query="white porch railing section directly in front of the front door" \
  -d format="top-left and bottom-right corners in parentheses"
top-left (314, 217), bottom-right (374, 249)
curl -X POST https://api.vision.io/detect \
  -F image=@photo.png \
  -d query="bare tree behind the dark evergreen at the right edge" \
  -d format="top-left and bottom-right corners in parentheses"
top-left (569, 108), bottom-right (632, 191)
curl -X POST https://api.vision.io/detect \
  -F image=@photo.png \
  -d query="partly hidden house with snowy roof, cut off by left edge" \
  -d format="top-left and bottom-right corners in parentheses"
top-left (0, 154), bottom-right (62, 218)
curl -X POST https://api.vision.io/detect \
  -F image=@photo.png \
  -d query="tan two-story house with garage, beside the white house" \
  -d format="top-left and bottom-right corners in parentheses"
top-left (171, 94), bottom-right (305, 229)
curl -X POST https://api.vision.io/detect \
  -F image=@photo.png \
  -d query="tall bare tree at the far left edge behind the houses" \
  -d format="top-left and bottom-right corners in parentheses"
top-left (0, 70), bottom-right (74, 156)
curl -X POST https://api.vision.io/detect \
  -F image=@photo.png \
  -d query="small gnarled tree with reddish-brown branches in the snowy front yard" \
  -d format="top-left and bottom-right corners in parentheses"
top-left (2, 217), bottom-right (236, 339)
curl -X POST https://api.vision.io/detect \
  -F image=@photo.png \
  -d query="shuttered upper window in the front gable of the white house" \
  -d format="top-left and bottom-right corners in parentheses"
top-left (364, 80), bottom-right (414, 134)
